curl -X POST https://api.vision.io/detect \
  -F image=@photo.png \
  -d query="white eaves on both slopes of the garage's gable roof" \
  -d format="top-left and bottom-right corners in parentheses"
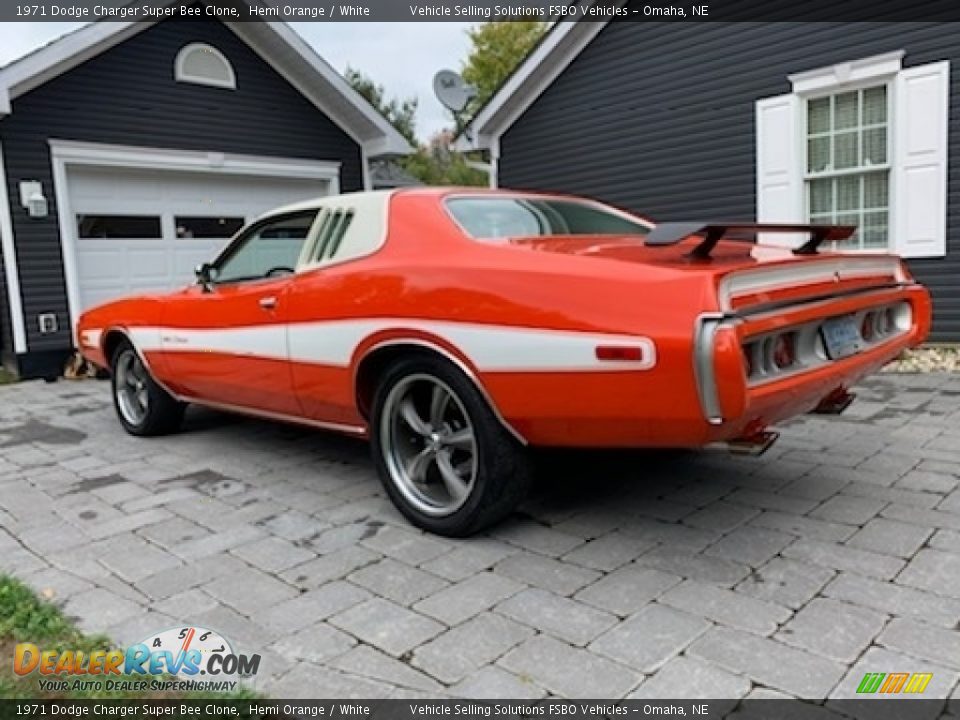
top-left (0, 0), bottom-right (413, 157)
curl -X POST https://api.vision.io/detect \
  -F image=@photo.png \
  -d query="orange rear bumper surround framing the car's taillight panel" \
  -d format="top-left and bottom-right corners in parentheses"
top-left (701, 284), bottom-right (931, 442)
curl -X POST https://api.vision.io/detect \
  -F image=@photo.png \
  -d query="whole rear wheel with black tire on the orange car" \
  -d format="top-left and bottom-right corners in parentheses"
top-left (371, 356), bottom-right (532, 537)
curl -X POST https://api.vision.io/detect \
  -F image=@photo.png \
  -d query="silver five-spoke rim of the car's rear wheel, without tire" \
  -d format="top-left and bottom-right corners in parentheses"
top-left (380, 374), bottom-right (479, 517)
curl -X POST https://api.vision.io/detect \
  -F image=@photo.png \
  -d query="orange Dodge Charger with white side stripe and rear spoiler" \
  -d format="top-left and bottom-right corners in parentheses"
top-left (77, 188), bottom-right (930, 535)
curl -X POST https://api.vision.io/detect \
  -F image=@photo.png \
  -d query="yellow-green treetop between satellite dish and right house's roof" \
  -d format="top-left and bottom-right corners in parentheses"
top-left (461, 20), bottom-right (547, 114)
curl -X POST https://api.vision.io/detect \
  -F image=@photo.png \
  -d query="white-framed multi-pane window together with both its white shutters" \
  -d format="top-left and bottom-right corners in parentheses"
top-left (755, 50), bottom-right (950, 258)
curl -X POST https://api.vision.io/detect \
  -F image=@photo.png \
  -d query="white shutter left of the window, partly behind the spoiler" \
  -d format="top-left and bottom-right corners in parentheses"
top-left (756, 94), bottom-right (806, 247)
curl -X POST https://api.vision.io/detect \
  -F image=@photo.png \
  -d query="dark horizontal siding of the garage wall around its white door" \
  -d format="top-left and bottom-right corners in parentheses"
top-left (0, 21), bottom-right (363, 360)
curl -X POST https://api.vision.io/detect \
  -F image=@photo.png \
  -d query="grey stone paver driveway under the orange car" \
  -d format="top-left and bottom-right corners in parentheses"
top-left (0, 375), bottom-right (960, 700)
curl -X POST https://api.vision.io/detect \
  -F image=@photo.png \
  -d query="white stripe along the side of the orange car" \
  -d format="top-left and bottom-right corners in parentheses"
top-left (124, 318), bottom-right (656, 372)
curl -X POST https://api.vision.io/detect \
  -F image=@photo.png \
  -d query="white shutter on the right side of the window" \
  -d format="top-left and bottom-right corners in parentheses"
top-left (891, 61), bottom-right (950, 257)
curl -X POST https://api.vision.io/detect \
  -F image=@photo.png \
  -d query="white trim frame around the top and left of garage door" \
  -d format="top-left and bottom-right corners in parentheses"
top-left (47, 140), bottom-right (340, 344)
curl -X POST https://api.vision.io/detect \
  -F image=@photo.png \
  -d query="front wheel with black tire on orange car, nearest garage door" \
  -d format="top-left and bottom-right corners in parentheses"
top-left (110, 340), bottom-right (186, 437)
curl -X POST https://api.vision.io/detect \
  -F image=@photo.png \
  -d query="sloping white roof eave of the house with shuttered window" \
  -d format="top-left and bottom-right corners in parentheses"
top-left (456, 14), bottom-right (608, 151)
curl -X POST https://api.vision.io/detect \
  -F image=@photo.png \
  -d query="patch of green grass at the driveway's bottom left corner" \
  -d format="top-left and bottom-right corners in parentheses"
top-left (0, 575), bottom-right (258, 700)
